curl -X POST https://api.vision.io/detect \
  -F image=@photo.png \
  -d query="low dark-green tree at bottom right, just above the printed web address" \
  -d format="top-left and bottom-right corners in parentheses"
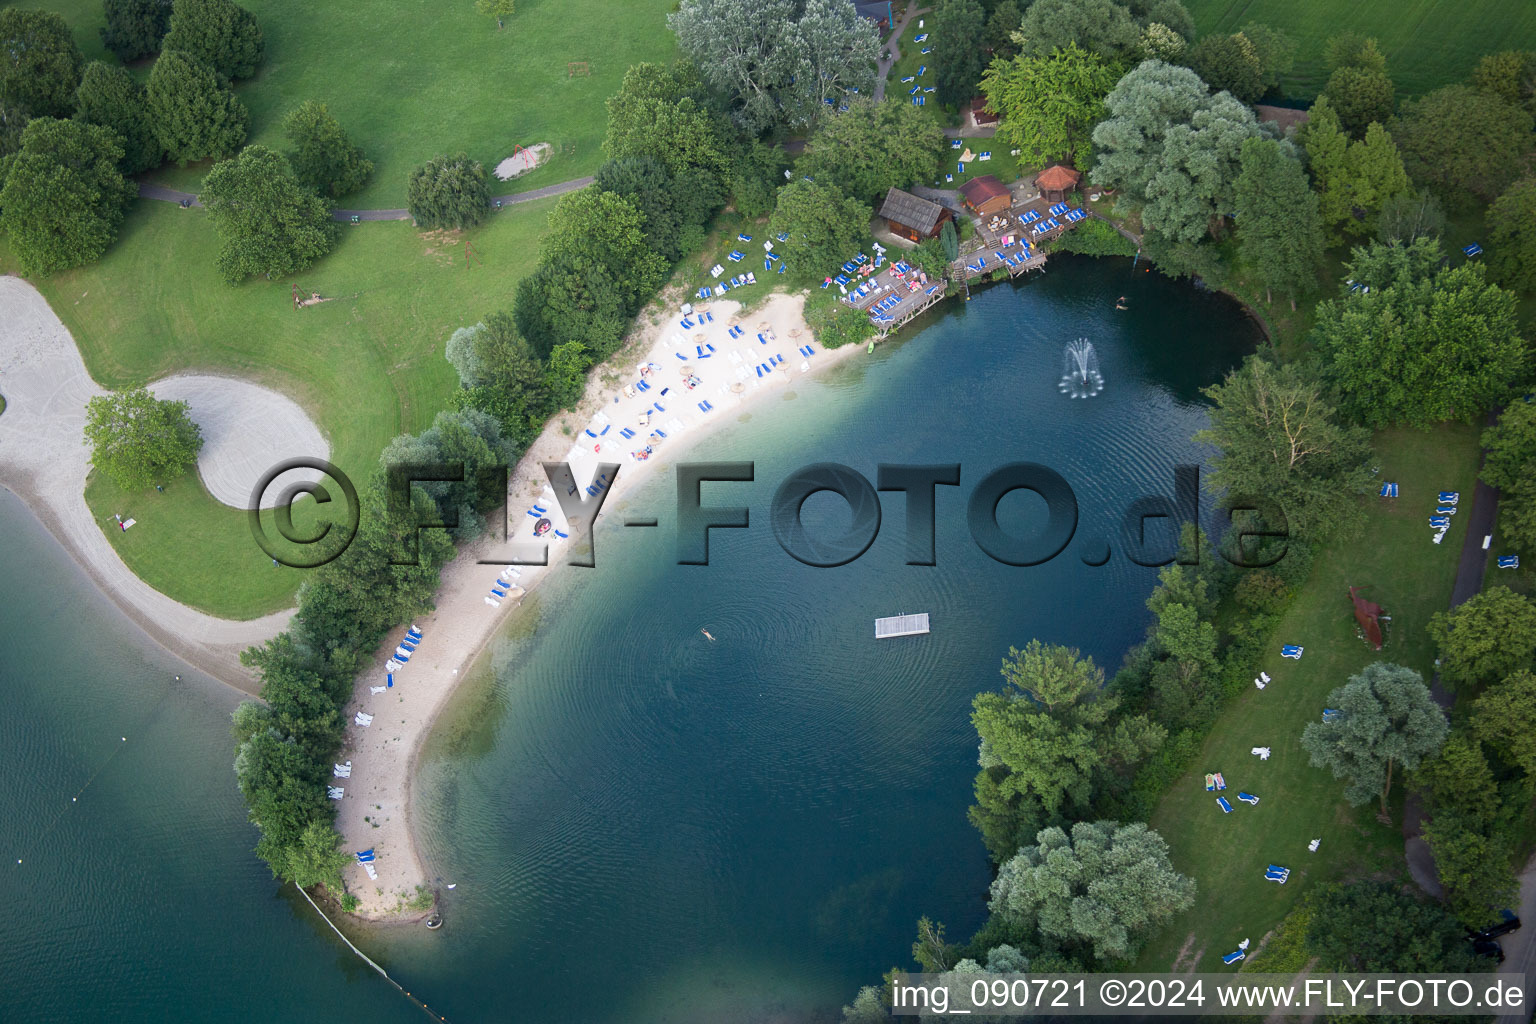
top-left (1307, 880), bottom-right (1484, 973)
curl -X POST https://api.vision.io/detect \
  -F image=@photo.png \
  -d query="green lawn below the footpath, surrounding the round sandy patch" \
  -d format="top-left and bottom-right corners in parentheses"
top-left (0, 200), bottom-right (554, 617)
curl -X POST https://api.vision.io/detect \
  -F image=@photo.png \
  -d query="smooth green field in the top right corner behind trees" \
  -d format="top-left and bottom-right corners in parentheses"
top-left (1184, 0), bottom-right (1536, 100)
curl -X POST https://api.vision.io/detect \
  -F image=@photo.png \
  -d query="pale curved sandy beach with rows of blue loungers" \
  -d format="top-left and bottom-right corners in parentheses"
top-left (330, 295), bottom-right (863, 921)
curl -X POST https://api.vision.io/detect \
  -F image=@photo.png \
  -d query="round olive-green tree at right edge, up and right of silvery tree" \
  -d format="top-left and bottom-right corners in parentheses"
top-left (1428, 586), bottom-right (1536, 689)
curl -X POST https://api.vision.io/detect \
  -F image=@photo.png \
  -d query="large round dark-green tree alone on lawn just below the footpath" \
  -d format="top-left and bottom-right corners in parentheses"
top-left (198, 146), bottom-right (336, 284)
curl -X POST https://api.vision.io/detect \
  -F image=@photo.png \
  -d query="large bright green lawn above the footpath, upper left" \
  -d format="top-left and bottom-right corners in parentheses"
top-left (28, 0), bottom-right (676, 209)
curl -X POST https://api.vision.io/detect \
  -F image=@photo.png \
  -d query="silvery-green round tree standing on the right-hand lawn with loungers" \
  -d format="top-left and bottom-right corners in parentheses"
top-left (1301, 662), bottom-right (1450, 817)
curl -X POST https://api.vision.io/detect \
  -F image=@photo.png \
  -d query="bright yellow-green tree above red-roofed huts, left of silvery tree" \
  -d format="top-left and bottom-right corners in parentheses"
top-left (982, 43), bottom-right (1117, 166)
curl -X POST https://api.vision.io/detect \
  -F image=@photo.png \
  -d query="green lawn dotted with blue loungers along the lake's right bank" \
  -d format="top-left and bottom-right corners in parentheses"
top-left (1140, 425), bottom-right (1478, 970)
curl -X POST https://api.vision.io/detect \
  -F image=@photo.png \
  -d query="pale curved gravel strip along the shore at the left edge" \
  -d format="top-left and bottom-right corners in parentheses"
top-left (0, 276), bottom-right (293, 691)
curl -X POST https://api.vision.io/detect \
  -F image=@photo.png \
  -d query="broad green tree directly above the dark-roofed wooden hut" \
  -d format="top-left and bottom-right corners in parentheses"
top-left (796, 98), bottom-right (945, 203)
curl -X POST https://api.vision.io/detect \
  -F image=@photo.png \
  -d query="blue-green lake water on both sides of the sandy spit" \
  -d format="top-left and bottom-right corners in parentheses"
top-left (0, 259), bottom-right (1258, 1022)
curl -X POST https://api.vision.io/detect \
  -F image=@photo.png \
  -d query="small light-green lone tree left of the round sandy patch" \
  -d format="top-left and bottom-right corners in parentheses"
top-left (84, 387), bottom-right (203, 491)
